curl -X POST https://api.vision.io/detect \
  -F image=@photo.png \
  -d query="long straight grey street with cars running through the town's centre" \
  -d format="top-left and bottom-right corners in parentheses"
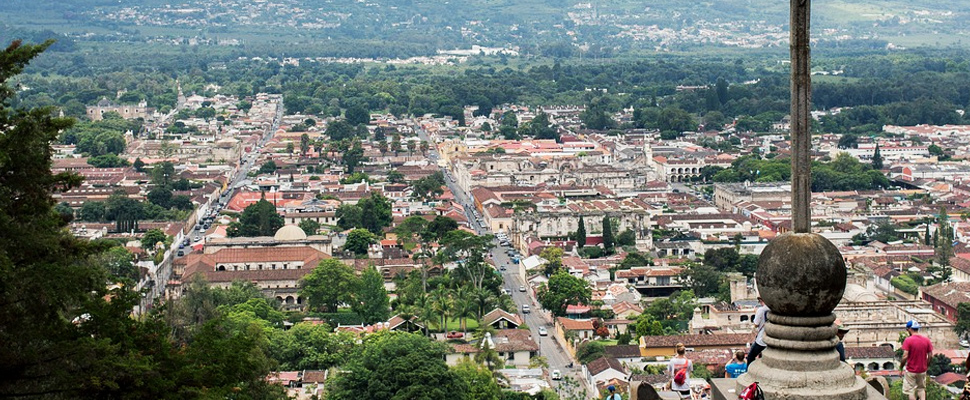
top-left (415, 123), bottom-right (585, 396)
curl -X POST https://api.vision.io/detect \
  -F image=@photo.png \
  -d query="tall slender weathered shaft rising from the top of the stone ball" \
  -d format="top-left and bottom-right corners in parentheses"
top-left (790, 0), bottom-right (812, 233)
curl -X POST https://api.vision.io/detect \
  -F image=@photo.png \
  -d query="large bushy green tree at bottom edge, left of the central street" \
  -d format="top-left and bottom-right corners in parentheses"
top-left (327, 332), bottom-right (468, 400)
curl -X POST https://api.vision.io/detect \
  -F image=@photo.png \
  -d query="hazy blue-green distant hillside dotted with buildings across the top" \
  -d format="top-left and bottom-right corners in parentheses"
top-left (0, 0), bottom-right (970, 57)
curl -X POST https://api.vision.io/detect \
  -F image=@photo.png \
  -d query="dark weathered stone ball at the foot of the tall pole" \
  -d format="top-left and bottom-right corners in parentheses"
top-left (756, 233), bottom-right (846, 316)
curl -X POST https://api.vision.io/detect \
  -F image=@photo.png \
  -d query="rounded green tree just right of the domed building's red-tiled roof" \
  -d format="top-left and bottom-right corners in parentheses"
top-left (300, 258), bottom-right (360, 312)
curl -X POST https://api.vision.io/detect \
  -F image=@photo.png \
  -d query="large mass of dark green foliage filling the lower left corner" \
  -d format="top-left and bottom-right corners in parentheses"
top-left (0, 42), bottom-right (280, 399)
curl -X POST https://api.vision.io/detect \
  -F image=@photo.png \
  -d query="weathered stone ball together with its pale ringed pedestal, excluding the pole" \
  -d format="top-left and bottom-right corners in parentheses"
top-left (736, 233), bottom-right (869, 400)
